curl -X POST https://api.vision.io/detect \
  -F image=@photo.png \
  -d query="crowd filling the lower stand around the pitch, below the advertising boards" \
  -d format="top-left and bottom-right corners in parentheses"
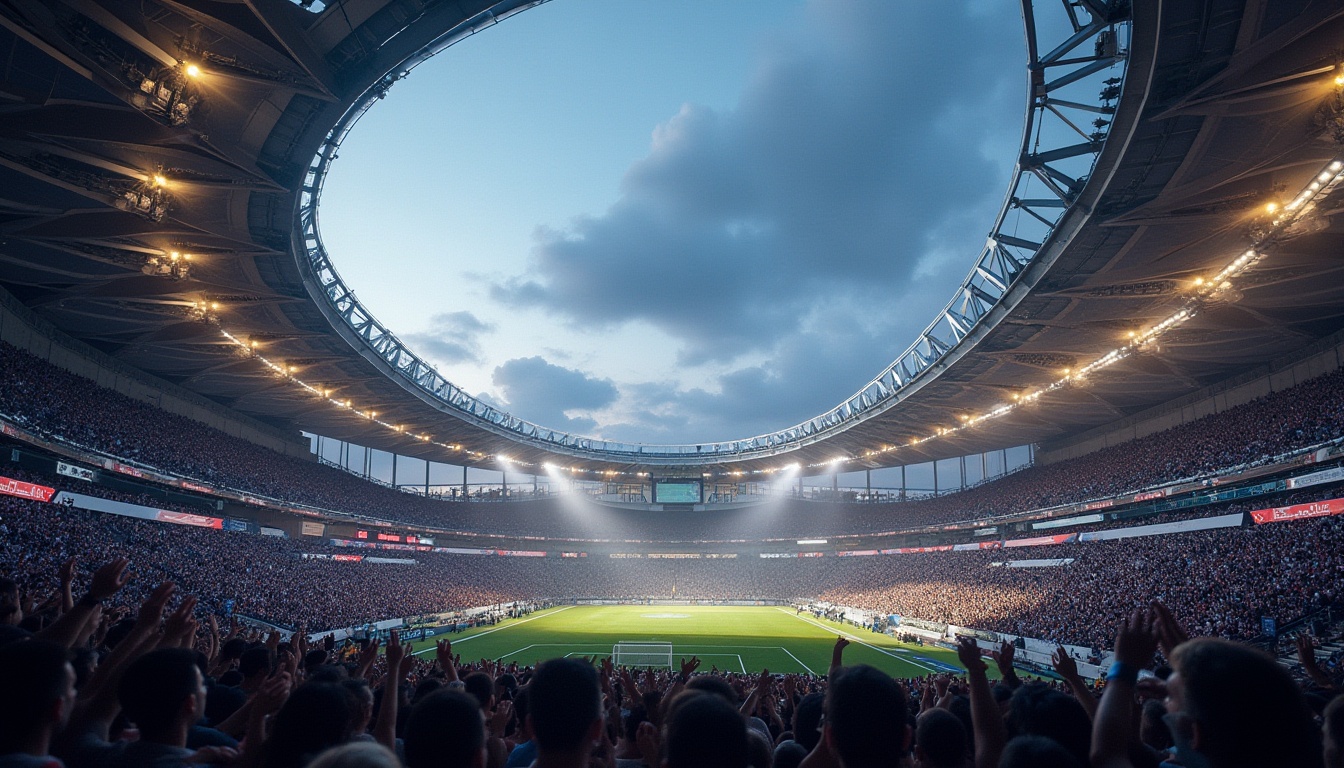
top-left (0, 462), bottom-right (1344, 647)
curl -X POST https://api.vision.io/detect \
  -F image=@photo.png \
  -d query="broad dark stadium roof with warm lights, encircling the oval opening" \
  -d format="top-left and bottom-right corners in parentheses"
top-left (0, 0), bottom-right (1344, 473)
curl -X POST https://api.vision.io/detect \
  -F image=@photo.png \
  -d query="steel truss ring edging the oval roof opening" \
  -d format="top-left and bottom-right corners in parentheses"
top-left (296, 0), bottom-right (1130, 464)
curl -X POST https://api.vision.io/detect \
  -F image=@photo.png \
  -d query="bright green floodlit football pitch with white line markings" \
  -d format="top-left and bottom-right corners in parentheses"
top-left (400, 605), bottom-right (993, 678)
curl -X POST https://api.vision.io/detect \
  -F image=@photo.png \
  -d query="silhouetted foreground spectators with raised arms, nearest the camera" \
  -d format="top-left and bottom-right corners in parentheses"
top-left (0, 557), bottom-right (1344, 768)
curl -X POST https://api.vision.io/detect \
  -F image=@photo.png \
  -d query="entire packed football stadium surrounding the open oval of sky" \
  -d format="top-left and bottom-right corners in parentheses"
top-left (0, 0), bottom-right (1344, 768)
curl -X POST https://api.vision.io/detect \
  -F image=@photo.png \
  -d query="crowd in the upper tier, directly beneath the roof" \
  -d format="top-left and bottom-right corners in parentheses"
top-left (0, 343), bottom-right (1344, 541)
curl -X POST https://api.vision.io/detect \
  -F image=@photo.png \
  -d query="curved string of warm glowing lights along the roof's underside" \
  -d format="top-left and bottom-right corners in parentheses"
top-left (209, 159), bottom-right (1344, 477)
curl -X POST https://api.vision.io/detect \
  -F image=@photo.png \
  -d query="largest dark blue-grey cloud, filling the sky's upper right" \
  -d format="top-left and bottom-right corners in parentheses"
top-left (492, 0), bottom-right (1024, 365)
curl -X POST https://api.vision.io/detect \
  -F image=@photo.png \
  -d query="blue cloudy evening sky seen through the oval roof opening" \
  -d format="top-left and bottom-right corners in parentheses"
top-left (320, 0), bottom-right (1025, 444)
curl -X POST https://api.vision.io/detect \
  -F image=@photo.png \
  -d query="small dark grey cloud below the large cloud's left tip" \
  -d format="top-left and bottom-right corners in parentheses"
top-left (492, 356), bottom-right (618, 433)
